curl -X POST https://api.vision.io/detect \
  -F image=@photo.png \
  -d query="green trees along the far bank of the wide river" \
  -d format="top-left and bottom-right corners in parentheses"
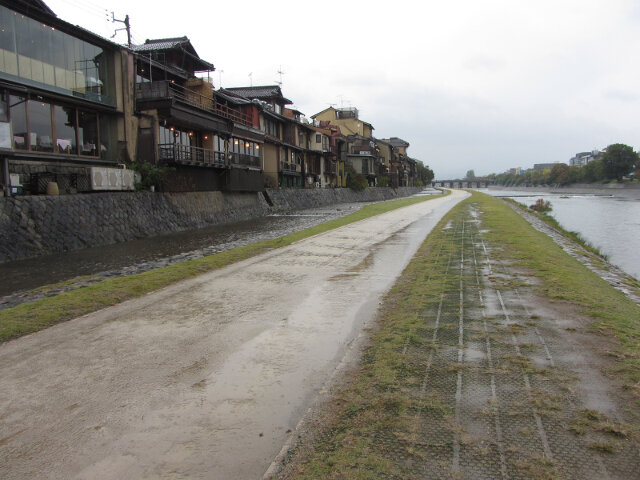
top-left (490, 143), bottom-right (640, 186)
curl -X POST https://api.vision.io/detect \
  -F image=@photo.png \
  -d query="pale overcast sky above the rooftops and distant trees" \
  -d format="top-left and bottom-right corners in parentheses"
top-left (45, 0), bottom-right (640, 179)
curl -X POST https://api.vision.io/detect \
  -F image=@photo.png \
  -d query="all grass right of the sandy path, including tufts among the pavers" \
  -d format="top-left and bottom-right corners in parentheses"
top-left (279, 193), bottom-right (640, 480)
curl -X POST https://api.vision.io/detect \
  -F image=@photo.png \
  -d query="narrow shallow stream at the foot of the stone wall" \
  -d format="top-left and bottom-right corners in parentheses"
top-left (0, 188), bottom-right (440, 304)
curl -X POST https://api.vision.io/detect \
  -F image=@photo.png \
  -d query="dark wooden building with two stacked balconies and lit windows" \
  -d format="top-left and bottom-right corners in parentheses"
top-left (132, 37), bottom-right (264, 191)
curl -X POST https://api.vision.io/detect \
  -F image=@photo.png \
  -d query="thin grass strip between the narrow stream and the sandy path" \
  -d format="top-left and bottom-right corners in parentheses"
top-left (0, 189), bottom-right (448, 342)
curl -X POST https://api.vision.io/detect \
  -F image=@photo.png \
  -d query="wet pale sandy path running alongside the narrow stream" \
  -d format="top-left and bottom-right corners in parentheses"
top-left (0, 192), bottom-right (467, 480)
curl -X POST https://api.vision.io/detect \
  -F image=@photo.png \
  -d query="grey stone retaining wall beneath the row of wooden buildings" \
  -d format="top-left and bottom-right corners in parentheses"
top-left (0, 187), bottom-right (421, 263)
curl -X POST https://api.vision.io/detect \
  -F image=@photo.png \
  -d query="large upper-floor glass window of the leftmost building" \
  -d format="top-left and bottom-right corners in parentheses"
top-left (0, 6), bottom-right (115, 105)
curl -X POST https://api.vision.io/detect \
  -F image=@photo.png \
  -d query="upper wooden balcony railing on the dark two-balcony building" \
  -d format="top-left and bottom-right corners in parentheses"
top-left (136, 80), bottom-right (251, 126)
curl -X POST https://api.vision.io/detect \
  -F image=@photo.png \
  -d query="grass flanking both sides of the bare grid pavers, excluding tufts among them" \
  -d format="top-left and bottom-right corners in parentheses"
top-left (280, 192), bottom-right (640, 480)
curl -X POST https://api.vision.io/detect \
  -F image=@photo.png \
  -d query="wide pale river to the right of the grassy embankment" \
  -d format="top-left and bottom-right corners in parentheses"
top-left (480, 188), bottom-right (640, 280)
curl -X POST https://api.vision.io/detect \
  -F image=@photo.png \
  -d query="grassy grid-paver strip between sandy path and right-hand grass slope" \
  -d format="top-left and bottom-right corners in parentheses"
top-left (273, 195), bottom-right (640, 480)
